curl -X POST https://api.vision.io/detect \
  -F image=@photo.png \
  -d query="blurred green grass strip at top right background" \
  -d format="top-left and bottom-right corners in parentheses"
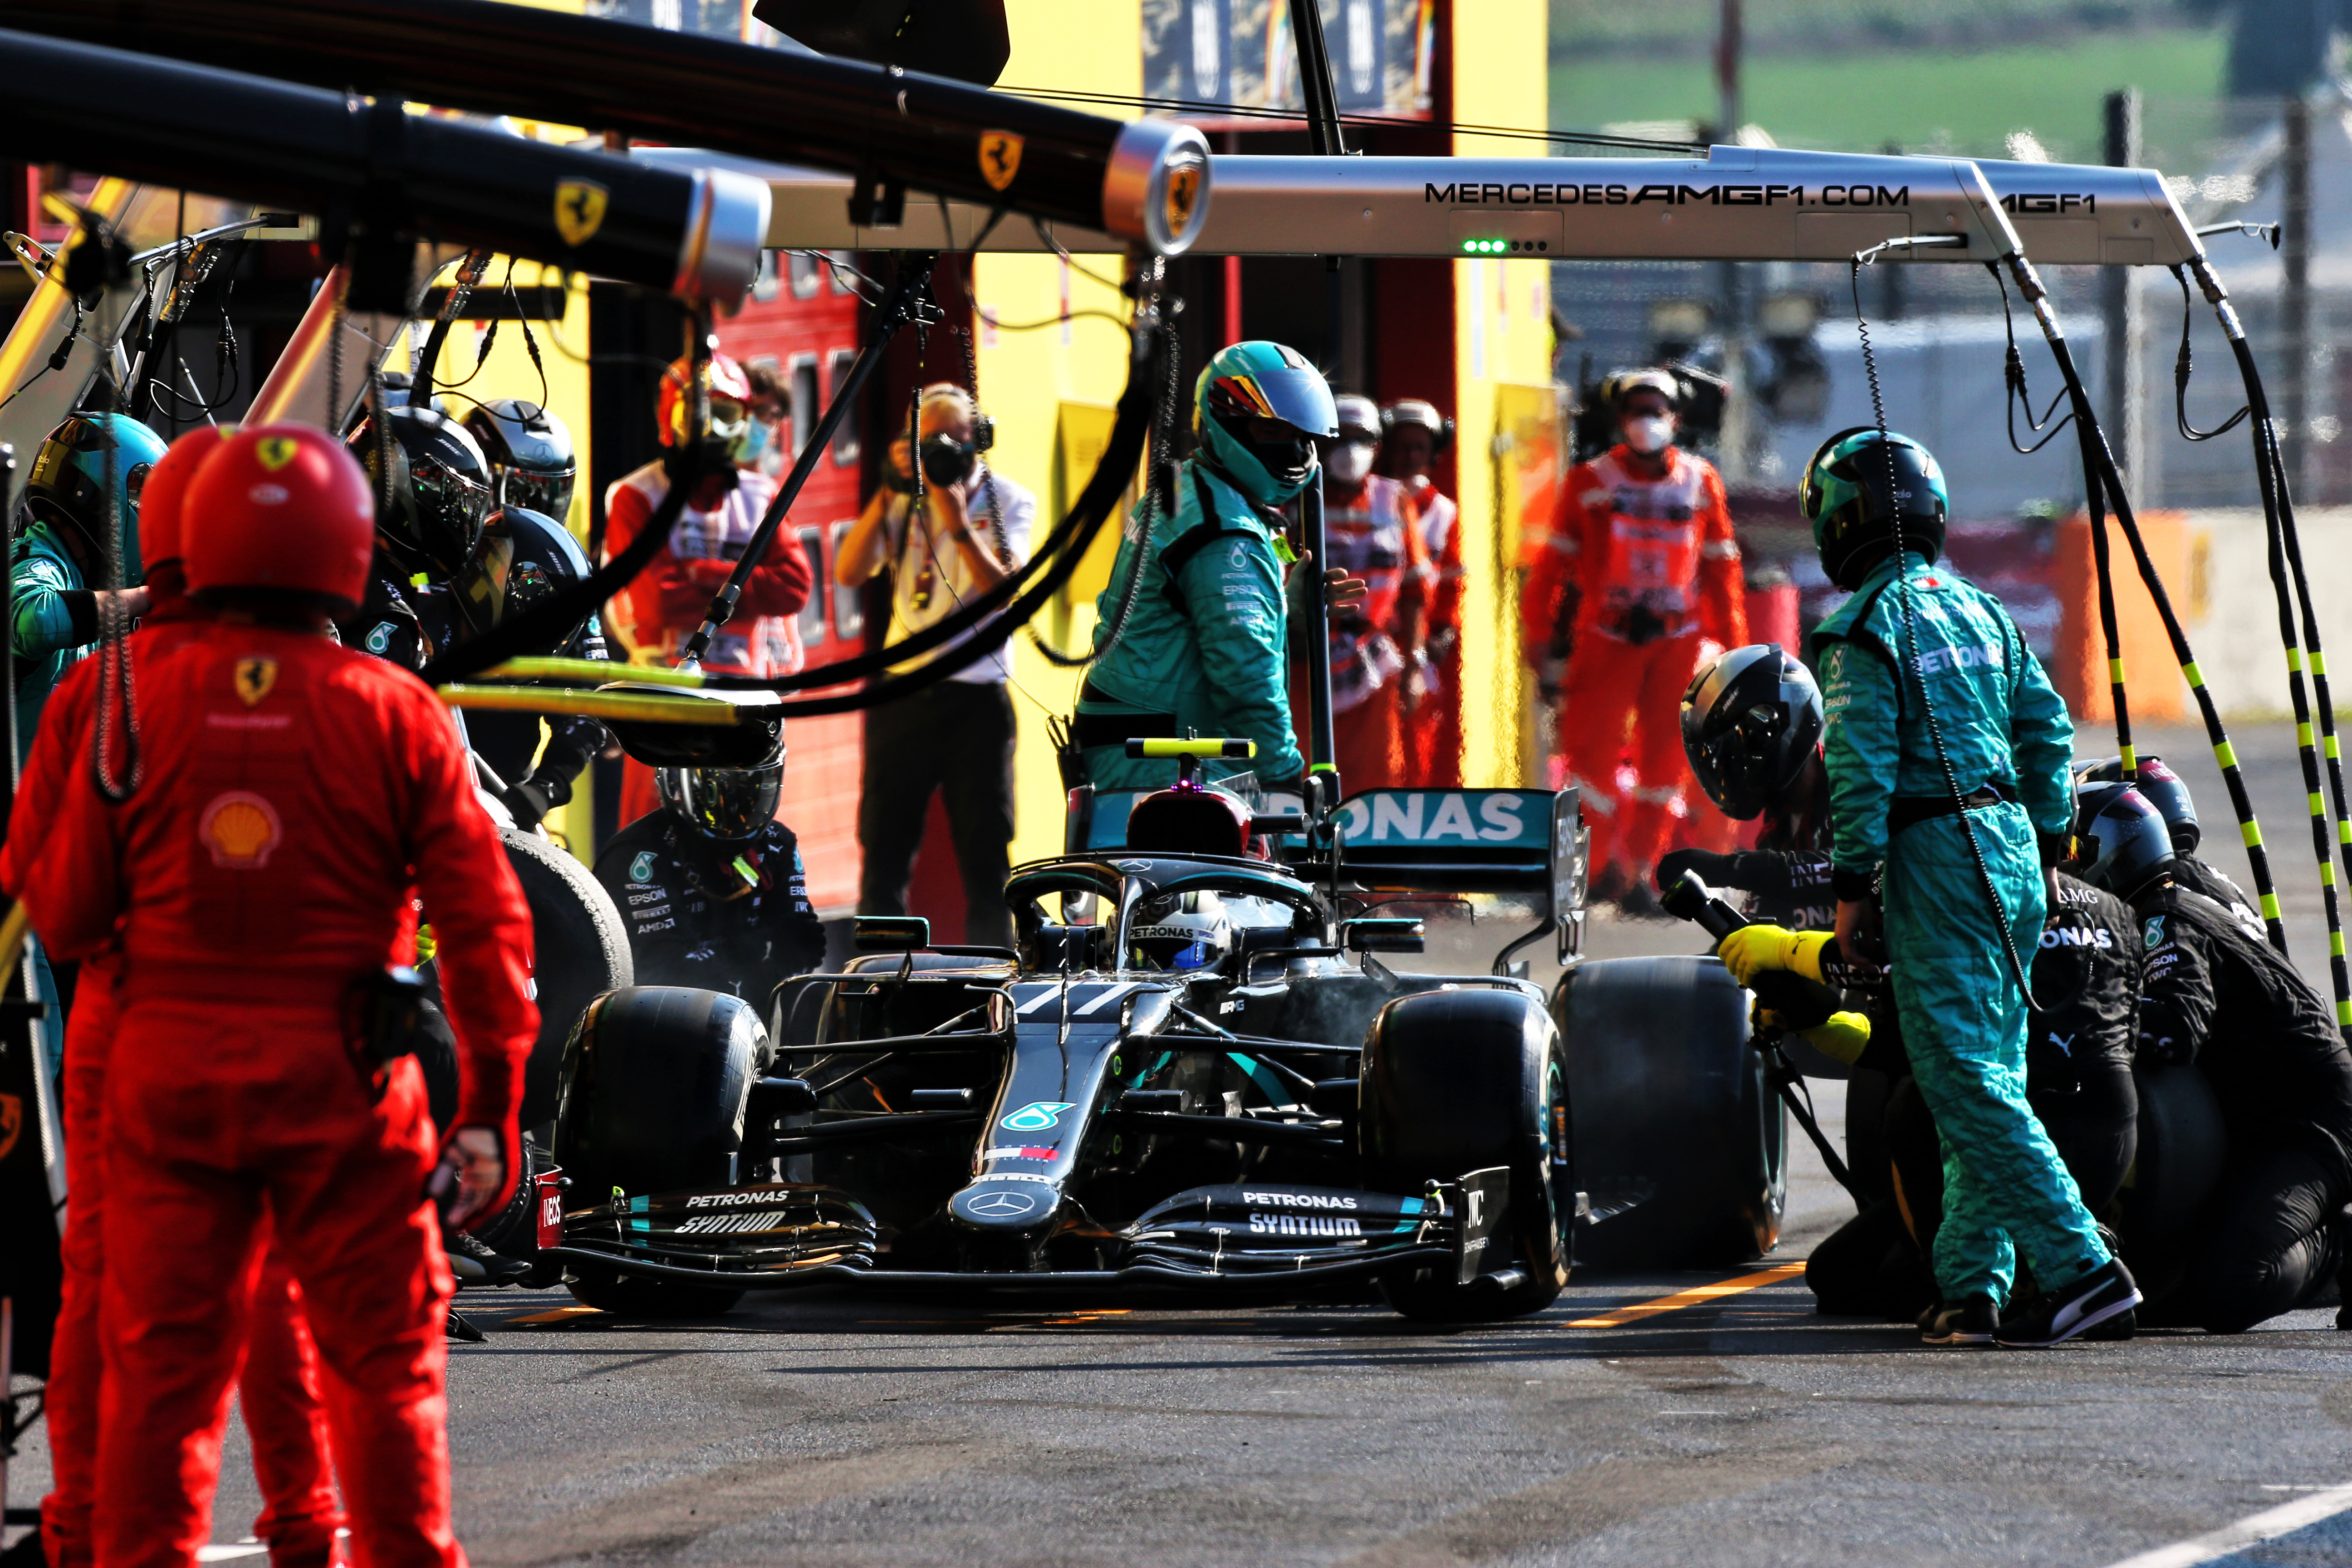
top-left (1552, 28), bottom-right (2227, 167)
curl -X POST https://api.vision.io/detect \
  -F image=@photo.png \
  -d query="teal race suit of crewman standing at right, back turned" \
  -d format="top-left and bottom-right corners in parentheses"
top-left (1816, 475), bottom-right (2107, 1305)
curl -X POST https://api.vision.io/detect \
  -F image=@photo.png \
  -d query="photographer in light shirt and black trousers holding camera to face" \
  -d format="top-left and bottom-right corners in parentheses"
top-left (833, 381), bottom-right (1037, 947)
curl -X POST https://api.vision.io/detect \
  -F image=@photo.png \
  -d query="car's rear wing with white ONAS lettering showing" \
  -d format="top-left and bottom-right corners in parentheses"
top-left (1338, 790), bottom-right (1590, 959)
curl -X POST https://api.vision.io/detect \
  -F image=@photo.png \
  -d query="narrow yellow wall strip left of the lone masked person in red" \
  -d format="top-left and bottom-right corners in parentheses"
top-left (1439, 0), bottom-right (1552, 785)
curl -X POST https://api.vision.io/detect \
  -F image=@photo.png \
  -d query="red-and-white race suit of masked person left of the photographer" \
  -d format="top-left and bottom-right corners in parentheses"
top-left (604, 461), bottom-right (811, 828)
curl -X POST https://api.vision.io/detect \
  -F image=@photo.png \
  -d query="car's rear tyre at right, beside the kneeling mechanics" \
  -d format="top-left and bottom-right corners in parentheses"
top-left (1552, 955), bottom-right (1788, 1269)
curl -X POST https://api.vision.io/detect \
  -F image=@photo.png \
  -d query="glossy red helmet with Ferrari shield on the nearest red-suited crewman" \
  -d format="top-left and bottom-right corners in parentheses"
top-left (181, 426), bottom-right (376, 616)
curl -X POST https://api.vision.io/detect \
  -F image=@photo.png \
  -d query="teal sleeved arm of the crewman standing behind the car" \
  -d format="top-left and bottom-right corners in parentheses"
top-left (1176, 524), bottom-right (1305, 783)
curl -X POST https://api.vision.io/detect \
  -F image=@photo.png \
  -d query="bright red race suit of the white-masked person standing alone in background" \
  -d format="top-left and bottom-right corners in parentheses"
top-left (1524, 446), bottom-right (1748, 879)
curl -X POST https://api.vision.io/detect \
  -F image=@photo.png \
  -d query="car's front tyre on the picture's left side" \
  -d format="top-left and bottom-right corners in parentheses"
top-left (555, 985), bottom-right (769, 1317)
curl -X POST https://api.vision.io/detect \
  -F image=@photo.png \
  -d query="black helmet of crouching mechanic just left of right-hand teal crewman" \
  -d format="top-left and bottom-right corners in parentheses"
top-left (1682, 642), bottom-right (1823, 823)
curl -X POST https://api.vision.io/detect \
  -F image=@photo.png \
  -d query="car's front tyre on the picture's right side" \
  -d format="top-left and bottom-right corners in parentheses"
top-left (1359, 987), bottom-right (1573, 1323)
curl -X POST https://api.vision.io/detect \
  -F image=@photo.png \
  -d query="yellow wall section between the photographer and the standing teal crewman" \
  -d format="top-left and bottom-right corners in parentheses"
top-left (971, 0), bottom-right (1143, 863)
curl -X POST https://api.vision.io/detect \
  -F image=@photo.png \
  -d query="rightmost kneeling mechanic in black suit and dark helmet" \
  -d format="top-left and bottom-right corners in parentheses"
top-left (2074, 783), bottom-right (2352, 1333)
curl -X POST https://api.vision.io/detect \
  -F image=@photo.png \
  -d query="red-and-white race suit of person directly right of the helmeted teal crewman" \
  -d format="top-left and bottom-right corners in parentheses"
top-left (1324, 475), bottom-right (1432, 794)
